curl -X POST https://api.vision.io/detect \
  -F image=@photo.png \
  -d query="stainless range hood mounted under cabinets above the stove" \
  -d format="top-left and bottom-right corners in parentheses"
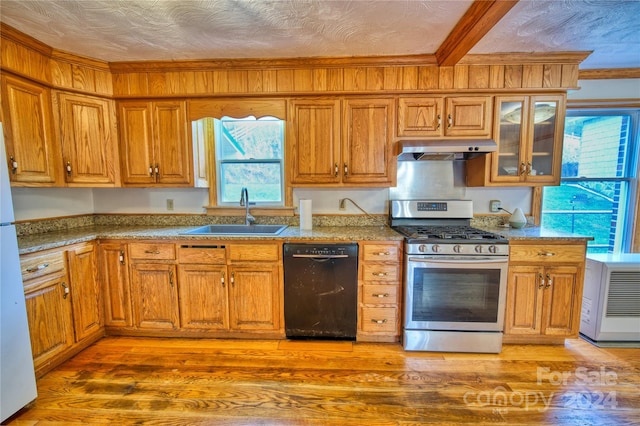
top-left (398, 139), bottom-right (498, 161)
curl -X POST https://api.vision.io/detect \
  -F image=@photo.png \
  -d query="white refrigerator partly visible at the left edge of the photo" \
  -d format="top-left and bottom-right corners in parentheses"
top-left (0, 123), bottom-right (37, 423)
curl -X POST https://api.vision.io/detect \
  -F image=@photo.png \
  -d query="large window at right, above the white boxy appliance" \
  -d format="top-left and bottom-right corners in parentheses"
top-left (541, 110), bottom-right (640, 253)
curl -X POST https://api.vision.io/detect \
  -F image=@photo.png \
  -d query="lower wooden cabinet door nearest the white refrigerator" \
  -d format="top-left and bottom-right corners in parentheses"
top-left (25, 275), bottom-right (73, 370)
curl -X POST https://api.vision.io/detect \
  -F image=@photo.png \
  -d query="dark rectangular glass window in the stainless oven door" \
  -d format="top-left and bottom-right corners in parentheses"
top-left (412, 268), bottom-right (500, 322)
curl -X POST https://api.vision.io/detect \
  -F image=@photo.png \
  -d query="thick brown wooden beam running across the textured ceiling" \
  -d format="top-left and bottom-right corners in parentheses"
top-left (435, 0), bottom-right (518, 66)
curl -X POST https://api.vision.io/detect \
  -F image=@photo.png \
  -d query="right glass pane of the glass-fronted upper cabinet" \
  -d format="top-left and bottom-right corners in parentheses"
top-left (527, 102), bottom-right (558, 176)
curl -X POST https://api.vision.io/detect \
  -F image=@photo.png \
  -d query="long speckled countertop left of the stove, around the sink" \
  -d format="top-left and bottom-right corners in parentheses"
top-left (18, 226), bottom-right (404, 254)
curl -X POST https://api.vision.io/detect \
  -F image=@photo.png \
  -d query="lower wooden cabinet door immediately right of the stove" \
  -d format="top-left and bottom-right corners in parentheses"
top-left (504, 266), bottom-right (544, 334)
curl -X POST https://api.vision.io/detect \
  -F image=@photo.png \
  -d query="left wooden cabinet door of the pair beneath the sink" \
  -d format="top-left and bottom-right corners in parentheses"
top-left (178, 264), bottom-right (229, 330)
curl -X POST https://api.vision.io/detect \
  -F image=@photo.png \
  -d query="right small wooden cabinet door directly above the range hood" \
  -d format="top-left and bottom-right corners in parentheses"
top-left (443, 96), bottom-right (491, 139)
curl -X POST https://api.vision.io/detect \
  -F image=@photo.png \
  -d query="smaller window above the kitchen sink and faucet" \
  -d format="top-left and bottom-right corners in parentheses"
top-left (214, 117), bottom-right (284, 206)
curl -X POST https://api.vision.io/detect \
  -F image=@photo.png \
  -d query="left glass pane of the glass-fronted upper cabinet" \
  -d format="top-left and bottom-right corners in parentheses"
top-left (498, 100), bottom-right (525, 176)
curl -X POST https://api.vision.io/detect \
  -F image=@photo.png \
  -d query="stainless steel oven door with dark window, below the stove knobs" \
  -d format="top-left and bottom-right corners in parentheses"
top-left (405, 255), bottom-right (508, 331)
